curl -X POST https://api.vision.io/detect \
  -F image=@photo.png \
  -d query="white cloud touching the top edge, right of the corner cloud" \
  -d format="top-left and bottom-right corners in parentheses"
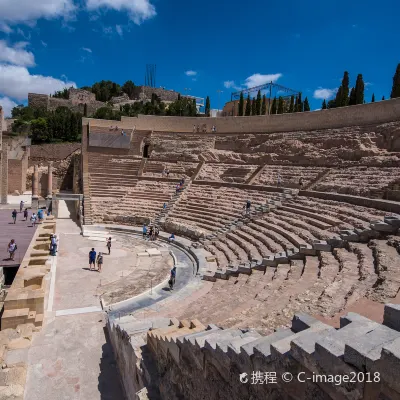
top-left (86, 0), bottom-right (157, 25)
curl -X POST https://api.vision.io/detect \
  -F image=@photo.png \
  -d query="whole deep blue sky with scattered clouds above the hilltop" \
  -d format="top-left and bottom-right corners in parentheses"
top-left (0, 0), bottom-right (400, 112)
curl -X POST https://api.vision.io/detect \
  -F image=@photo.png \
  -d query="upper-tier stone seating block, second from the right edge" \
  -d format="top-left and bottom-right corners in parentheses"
top-left (254, 165), bottom-right (326, 187)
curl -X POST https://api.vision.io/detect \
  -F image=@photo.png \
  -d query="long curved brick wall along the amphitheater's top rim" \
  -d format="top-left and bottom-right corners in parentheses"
top-left (118, 98), bottom-right (400, 133)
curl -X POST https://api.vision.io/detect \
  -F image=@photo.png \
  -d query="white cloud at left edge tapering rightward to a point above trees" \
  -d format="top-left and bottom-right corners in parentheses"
top-left (0, 64), bottom-right (76, 100)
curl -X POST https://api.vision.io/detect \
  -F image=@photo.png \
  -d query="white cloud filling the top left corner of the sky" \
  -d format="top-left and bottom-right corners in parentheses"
top-left (0, 0), bottom-right (76, 31)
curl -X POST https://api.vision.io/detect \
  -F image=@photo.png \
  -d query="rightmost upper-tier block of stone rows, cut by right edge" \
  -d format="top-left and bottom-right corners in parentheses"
top-left (314, 167), bottom-right (400, 196)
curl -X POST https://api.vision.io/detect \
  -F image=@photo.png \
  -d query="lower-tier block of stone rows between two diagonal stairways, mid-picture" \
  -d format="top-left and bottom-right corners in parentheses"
top-left (168, 183), bottom-right (272, 233)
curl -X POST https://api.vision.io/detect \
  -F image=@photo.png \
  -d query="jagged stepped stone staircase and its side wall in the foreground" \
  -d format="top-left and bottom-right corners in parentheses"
top-left (108, 304), bottom-right (400, 400)
